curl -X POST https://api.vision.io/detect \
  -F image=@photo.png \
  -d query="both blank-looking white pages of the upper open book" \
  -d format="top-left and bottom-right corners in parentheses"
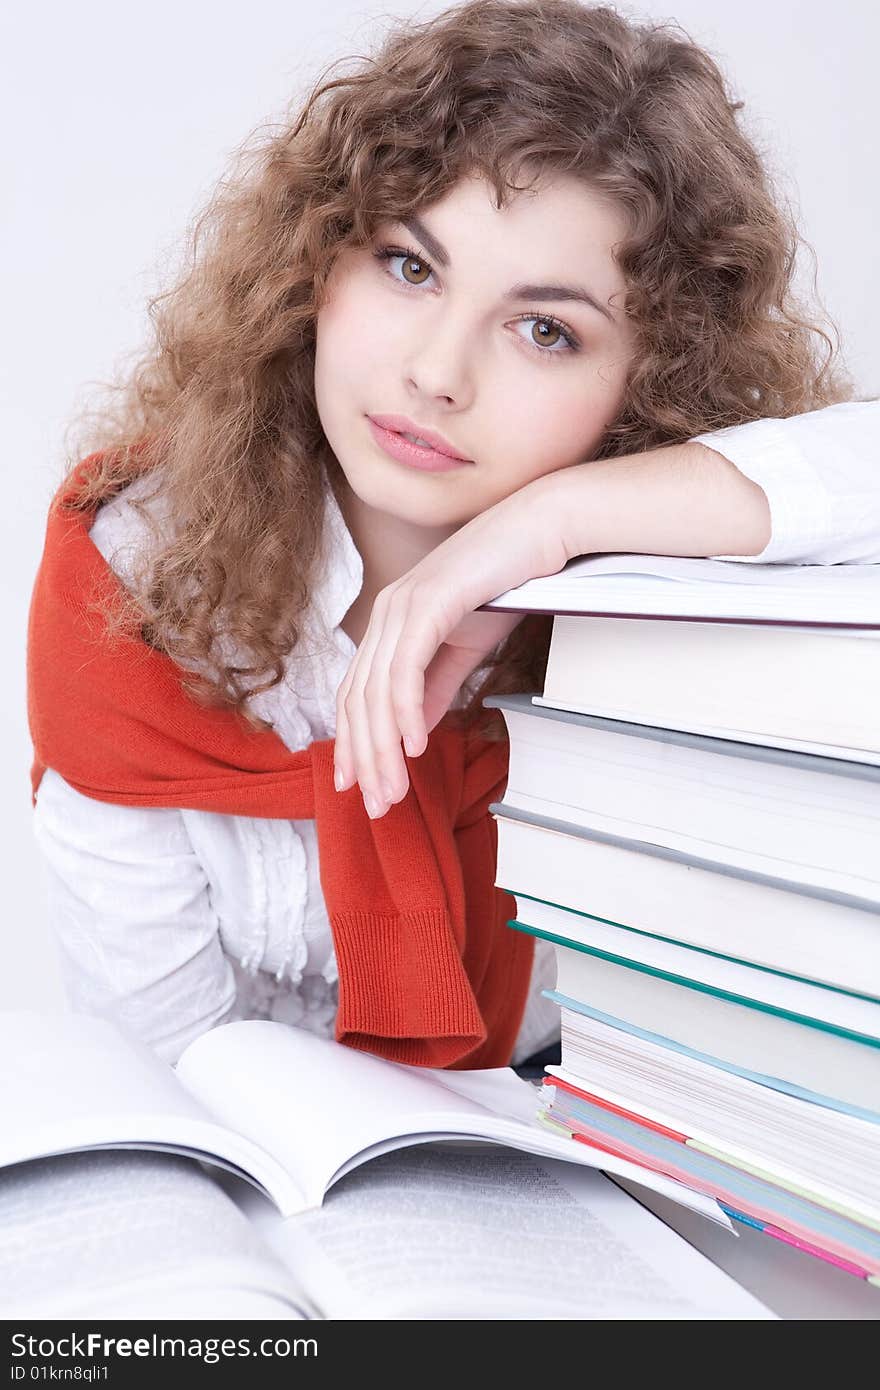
top-left (0, 1011), bottom-right (728, 1225)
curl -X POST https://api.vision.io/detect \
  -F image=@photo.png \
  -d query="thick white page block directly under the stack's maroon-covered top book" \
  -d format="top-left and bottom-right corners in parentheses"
top-left (532, 616), bottom-right (880, 763)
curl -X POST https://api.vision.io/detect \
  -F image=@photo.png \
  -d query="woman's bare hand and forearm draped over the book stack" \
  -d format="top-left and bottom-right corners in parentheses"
top-left (335, 442), bottom-right (772, 816)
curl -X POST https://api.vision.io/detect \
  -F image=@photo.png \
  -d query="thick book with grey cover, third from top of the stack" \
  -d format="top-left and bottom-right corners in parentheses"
top-left (484, 695), bottom-right (880, 902)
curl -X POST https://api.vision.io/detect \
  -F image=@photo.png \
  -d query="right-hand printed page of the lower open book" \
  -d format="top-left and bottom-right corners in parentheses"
top-left (229, 1145), bottom-right (774, 1321)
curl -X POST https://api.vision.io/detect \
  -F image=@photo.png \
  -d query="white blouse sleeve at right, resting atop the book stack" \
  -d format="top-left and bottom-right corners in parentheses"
top-left (691, 400), bottom-right (880, 564)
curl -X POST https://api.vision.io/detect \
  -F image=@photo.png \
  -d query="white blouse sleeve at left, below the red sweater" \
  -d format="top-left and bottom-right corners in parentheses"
top-left (33, 769), bottom-right (235, 1063)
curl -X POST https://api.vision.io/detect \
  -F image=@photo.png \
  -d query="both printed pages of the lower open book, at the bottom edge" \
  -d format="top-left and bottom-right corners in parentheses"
top-left (0, 1145), bottom-right (772, 1321)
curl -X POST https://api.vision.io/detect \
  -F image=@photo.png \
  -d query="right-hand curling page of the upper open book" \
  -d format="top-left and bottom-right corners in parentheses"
top-left (177, 1019), bottom-right (730, 1226)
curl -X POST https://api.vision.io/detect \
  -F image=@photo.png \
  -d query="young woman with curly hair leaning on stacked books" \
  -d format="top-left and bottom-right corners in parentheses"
top-left (23, 0), bottom-right (880, 1066)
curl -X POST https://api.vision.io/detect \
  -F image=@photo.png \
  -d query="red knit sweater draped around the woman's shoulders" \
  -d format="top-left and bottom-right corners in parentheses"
top-left (28, 455), bottom-right (532, 1068)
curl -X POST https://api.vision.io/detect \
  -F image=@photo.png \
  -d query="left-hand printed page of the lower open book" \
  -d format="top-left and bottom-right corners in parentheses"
top-left (0, 1152), bottom-right (309, 1319)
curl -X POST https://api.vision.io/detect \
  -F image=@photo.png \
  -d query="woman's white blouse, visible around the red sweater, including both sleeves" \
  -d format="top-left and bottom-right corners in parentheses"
top-left (33, 402), bottom-right (880, 1063)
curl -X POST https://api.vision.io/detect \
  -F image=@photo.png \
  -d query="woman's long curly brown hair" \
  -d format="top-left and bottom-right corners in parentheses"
top-left (60, 0), bottom-right (852, 727)
